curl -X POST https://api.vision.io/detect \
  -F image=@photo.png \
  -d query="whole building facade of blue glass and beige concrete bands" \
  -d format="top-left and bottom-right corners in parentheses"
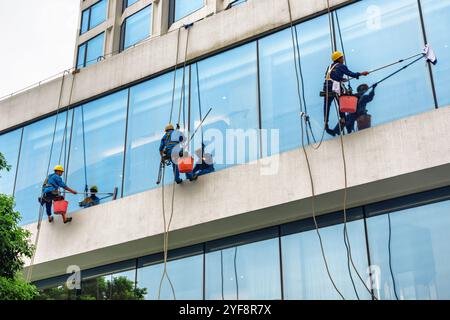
top-left (0, 0), bottom-right (450, 300)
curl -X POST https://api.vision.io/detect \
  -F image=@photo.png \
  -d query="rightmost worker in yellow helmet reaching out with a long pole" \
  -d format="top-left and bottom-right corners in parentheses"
top-left (323, 51), bottom-right (369, 136)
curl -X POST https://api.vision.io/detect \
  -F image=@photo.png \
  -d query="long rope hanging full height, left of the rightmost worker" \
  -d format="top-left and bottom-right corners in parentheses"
top-left (287, 0), bottom-right (345, 300)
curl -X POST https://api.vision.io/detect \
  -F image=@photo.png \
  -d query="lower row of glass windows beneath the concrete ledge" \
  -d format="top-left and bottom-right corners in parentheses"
top-left (33, 193), bottom-right (450, 300)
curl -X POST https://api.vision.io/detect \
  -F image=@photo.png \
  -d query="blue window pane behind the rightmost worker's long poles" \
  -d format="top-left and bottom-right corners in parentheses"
top-left (337, 0), bottom-right (434, 129)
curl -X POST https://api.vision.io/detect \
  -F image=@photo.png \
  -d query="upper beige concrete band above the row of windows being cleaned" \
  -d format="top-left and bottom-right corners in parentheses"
top-left (0, 0), bottom-right (349, 132)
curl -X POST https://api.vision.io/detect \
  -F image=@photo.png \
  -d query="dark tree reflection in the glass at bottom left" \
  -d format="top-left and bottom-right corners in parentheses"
top-left (38, 277), bottom-right (147, 300)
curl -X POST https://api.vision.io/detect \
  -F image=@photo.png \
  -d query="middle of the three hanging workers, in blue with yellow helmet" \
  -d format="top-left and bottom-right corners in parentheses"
top-left (159, 124), bottom-right (184, 184)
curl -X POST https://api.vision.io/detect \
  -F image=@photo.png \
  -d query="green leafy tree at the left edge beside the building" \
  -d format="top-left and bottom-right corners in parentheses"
top-left (0, 153), bottom-right (37, 300)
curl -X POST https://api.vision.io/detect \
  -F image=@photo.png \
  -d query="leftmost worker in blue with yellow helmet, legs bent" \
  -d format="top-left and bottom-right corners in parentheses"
top-left (39, 165), bottom-right (77, 223)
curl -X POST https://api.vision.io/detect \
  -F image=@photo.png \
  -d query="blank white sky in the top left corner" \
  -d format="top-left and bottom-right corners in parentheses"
top-left (0, 0), bottom-right (80, 97)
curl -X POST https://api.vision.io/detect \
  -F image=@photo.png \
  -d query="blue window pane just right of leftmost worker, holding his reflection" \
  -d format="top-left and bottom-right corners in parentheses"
top-left (67, 90), bottom-right (128, 211)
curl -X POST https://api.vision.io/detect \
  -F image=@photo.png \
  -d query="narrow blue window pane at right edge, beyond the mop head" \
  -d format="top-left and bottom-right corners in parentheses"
top-left (421, 0), bottom-right (450, 106)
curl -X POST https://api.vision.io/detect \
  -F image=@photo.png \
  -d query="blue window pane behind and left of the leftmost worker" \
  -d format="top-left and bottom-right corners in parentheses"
top-left (15, 111), bottom-right (72, 224)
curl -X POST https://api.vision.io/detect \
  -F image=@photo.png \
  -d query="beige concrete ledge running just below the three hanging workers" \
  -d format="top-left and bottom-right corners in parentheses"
top-left (23, 107), bottom-right (450, 280)
